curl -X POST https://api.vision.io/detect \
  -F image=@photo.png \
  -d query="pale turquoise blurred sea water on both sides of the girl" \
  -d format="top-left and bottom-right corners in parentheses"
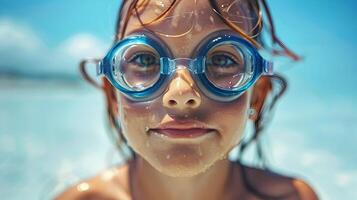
top-left (0, 79), bottom-right (357, 200)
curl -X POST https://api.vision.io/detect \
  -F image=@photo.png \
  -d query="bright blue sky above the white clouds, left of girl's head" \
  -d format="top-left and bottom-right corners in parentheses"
top-left (0, 0), bottom-right (120, 47)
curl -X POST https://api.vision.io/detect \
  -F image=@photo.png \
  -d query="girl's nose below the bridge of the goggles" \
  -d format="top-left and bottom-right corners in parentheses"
top-left (163, 69), bottom-right (202, 111)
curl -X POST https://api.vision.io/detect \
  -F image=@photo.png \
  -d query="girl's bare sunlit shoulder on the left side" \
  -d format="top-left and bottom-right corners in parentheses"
top-left (55, 164), bottom-right (131, 200)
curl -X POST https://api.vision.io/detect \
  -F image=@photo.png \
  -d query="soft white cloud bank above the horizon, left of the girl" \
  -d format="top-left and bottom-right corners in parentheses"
top-left (0, 18), bottom-right (109, 75)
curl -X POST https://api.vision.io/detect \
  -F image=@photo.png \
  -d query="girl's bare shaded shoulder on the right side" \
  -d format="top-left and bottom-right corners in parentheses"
top-left (237, 165), bottom-right (319, 200)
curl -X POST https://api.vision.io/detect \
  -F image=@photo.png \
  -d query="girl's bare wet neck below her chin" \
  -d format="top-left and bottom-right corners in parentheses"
top-left (132, 156), bottom-right (237, 200)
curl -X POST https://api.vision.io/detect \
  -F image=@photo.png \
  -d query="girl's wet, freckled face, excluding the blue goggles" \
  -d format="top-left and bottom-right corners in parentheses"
top-left (117, 0), bottom-right (252, 176)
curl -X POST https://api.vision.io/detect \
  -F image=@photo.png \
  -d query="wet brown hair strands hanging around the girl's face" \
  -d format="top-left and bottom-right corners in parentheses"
top-left (96, 0), bottom-right (299, 200)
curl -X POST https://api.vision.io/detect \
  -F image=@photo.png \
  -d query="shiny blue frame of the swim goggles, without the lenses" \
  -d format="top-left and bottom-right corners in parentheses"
top-left (97, 33), bottom-right (273, 102)
